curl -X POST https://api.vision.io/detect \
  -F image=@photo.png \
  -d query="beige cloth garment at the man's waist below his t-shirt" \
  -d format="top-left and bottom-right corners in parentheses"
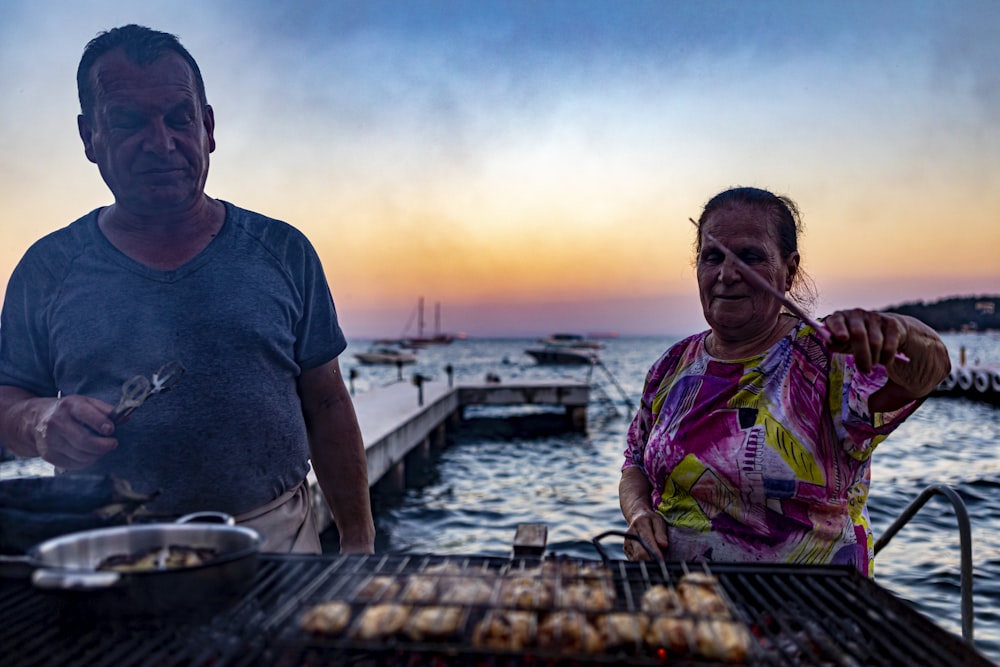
top-left (234, 480), bottom-right (323, 554)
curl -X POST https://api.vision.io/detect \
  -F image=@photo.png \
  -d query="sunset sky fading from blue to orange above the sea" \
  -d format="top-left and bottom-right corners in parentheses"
top-left (0, 0), bottom-right (1000, 338)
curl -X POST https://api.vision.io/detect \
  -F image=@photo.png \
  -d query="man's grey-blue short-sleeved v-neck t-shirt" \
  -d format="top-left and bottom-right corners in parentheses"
top-left (0, 203), bottom-right (347, 514)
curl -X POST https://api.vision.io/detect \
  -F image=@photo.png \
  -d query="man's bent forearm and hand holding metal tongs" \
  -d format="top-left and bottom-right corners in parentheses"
top-left (0, 386), bottom-right (118, 470)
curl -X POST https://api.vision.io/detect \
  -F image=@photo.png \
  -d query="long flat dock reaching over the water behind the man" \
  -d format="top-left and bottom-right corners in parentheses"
top-left (309, 380), bottom-right (590, 531)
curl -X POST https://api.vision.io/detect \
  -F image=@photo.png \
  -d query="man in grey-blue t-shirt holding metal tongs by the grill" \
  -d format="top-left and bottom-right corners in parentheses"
top-left (0, 25), bottom-right (375, 553)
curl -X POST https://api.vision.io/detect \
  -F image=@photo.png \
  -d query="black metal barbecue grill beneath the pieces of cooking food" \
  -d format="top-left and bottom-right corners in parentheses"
top-left (0, 554), bottom-right (993, 667)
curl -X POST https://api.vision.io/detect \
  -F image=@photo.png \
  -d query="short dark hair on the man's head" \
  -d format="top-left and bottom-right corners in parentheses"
top-left (76, 24), bottom-right (208, 116)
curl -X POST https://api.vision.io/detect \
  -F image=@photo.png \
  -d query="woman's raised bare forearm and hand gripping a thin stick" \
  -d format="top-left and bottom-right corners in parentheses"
top-left (823, 308), bottom-right (951, 412)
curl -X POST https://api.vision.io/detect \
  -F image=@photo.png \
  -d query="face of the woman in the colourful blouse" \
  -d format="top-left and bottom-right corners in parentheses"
top-left (698, 205), bottom-right (799, 342)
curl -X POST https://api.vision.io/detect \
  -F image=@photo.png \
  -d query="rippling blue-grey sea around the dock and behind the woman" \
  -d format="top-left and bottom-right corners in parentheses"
top-left (352, 333), bottom-right (1000, 662)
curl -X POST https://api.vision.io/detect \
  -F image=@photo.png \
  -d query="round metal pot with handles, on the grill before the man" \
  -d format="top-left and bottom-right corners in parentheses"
top-left (4, 512), bottom-right (261, 615)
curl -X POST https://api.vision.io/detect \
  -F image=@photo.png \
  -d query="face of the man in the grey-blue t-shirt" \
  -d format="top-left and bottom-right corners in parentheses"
top-left (78, 50), bottom-right (215, 216)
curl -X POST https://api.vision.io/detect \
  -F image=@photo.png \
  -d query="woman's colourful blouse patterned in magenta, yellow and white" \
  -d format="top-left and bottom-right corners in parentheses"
top-left (622, 324), bottom-right (919, 576)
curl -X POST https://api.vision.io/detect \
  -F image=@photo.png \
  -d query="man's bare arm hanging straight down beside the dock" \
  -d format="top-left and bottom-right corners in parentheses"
top-left (299, 359), bottom-right (375, 554)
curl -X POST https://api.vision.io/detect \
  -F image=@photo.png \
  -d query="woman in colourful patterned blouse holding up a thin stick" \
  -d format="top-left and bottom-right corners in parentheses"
top-left (619, 188), bottom-right (950, 576)
